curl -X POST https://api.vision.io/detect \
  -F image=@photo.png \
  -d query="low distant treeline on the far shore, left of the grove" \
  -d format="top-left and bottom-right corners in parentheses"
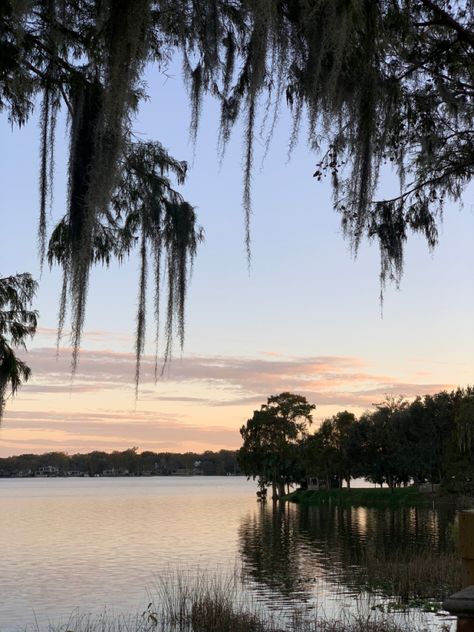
top-left (0, 448), bottom-right (240, 477)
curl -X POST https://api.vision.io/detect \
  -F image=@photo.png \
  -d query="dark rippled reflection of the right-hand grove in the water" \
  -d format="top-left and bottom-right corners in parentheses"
top-left (239, 503), bottom-right (455, 599)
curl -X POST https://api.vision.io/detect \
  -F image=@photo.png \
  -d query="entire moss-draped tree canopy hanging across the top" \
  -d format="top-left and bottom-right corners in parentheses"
top-left (0, 0), bottom-right (474, 390)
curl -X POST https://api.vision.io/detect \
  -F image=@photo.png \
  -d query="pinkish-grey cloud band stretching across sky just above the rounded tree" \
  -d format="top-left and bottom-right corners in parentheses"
top-left (18, 347), bottom-right (452, 406)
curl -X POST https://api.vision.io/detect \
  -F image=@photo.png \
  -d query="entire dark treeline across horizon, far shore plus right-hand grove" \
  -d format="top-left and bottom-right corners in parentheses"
top-left (0, 387), bottom-right (474, 496)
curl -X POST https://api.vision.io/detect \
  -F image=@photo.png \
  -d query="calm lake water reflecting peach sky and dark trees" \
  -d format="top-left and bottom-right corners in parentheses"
top-left (0, 477), bottom-right (460, 632)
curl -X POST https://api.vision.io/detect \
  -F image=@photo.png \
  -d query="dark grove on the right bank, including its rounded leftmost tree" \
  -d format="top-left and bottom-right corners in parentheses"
top-left (238, 387), bottom-right (474, 497)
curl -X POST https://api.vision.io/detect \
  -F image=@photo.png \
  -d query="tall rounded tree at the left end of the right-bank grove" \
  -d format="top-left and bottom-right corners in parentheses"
top-left (238, 393), bottom-right (315, 498)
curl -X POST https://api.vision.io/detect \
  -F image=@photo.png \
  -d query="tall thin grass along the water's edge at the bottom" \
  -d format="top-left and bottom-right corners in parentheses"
top-left (45, 573), bottom-right (449, 632)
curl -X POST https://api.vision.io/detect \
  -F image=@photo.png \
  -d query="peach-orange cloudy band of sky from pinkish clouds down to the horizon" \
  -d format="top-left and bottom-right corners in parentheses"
top-left (0, 347), bottom-right (453, 455)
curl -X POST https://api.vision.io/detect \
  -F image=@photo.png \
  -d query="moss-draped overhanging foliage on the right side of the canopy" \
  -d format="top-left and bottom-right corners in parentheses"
top-left (159, 0), bottom-right (474, 284)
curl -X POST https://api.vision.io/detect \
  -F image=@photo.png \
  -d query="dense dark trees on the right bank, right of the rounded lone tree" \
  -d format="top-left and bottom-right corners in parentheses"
top-left (299, 387), bottom-right (474, 497)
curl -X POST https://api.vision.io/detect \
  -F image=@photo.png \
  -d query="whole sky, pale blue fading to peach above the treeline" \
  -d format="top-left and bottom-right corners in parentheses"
top-left (0, 60), bottom-right (474, 457)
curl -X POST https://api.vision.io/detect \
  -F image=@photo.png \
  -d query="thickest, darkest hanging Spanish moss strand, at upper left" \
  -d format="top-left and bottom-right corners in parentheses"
top-left (59, 0), bottom-right (150, 372)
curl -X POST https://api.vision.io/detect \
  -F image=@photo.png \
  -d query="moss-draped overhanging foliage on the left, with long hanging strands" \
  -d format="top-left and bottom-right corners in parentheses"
top-left (0, 0), bottom-right (202, 385)
